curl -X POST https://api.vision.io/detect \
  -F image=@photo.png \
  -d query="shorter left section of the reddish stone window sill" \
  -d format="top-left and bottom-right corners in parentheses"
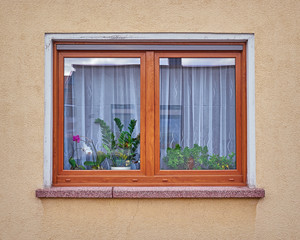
top-left (35, 187), bottom-right (112, 198)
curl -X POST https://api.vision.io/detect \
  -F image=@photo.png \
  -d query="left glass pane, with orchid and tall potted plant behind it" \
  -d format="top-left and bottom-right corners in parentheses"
top-left (64, 58), bottom-right (140, 170)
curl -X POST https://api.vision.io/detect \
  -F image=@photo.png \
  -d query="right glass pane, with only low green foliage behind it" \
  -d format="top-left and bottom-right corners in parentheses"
top-left (160, 58), bottom-right (236, 170)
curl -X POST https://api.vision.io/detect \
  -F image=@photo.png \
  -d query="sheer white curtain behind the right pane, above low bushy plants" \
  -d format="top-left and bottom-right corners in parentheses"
top-left (160, 65), bottom-right (236, 169)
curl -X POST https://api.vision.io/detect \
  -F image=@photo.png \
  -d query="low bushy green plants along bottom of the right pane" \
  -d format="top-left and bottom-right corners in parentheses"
top-left (163, 144), bottom-right (235, 170)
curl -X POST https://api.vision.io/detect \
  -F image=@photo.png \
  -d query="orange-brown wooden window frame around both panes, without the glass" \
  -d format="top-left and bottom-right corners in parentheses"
top-left (52, 42), bottom-right (247, 186)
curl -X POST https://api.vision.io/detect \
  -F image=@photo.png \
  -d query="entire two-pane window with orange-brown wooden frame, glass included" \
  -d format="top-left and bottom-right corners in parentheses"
top-left (52, 41), bottom-right (247, 186)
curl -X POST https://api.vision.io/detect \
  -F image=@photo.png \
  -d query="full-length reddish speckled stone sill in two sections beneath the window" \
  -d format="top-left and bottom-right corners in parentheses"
top-left (36, 187), bottom-right (265, 199)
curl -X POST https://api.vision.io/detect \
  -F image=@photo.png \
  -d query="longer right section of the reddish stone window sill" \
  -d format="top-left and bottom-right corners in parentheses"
top-left (113, 187), bottom-right (265, 198)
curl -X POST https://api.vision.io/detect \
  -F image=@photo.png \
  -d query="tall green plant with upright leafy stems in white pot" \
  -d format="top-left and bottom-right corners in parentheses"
top-left (95, 118), bottom-right (140, 170)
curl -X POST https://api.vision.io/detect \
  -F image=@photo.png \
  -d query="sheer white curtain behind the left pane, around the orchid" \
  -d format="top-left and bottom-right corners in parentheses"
top-left (64, 64), bottom-right (140, 169)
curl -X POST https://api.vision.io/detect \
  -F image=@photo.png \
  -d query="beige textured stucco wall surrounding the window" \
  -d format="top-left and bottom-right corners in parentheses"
top-left (0, 0), bottom-right (300, 239)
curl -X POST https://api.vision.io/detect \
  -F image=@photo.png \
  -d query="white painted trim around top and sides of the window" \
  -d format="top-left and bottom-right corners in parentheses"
top-left (44, 33), bottom-right (256, 187)
